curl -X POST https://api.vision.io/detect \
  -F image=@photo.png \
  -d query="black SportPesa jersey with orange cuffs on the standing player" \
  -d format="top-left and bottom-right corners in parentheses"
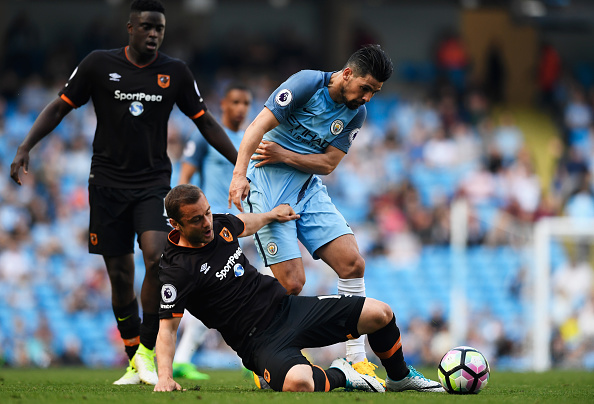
top-left (60, 47), bottom-right (206, 188)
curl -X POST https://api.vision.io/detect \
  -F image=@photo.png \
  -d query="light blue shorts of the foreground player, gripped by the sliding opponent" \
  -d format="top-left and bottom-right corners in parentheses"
top-left (243, 170), bottom-right (353, 266)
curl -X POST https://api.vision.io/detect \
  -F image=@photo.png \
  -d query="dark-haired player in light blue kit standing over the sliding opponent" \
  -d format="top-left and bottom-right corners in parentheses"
top-left (229, 45), bottom-right (393, 386)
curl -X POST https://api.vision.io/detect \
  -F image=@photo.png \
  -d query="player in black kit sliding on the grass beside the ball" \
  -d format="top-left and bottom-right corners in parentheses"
top-left (155, 185), bottom-right (444, 392)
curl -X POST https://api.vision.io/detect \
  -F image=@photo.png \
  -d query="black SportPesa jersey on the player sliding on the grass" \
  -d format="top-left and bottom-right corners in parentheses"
top-left (159, 214), bottom-right (287, 351)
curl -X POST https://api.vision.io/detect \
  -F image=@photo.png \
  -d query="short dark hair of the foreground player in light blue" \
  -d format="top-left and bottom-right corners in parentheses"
top-left (344, 45), bottom-right (394, 83)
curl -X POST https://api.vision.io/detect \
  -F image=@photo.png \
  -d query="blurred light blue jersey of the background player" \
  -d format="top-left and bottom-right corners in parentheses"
top-left (182, 126), bottom-right (244, 214)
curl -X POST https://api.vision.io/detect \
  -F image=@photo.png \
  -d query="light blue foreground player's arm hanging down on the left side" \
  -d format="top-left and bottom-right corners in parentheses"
top-left (229, 108), bottom-right (279, 212)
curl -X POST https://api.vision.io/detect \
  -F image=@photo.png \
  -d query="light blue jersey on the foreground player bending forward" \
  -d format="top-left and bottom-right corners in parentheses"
top-left (247, 70), bottom-right (367, 193)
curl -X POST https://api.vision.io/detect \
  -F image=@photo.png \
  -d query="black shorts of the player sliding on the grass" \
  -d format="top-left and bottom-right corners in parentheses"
top-left (240, 295), bottom-right (365, 391)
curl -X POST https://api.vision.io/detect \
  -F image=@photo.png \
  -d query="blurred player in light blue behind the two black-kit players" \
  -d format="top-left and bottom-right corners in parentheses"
top-left (173, 83), bottom-right (252, 380)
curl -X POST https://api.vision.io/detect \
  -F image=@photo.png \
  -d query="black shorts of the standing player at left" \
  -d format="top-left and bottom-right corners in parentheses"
top-left (89, 184), bottom-right (172, 256)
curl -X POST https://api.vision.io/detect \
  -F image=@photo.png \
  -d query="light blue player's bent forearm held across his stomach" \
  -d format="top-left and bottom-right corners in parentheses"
top-left (252, 140), bottom-right (346, 175)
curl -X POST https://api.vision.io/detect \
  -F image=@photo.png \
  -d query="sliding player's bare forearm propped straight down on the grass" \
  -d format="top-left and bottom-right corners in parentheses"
top-left (154, 317), bottom-right (181, 391)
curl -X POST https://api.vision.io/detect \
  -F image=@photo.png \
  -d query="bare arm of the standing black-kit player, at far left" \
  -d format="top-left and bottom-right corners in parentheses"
top-left (10, 98), bottom-right (72, 185)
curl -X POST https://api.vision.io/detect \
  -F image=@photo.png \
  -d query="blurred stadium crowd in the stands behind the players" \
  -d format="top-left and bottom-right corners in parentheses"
top-left (0, 7), bottom-right (594, 370)
